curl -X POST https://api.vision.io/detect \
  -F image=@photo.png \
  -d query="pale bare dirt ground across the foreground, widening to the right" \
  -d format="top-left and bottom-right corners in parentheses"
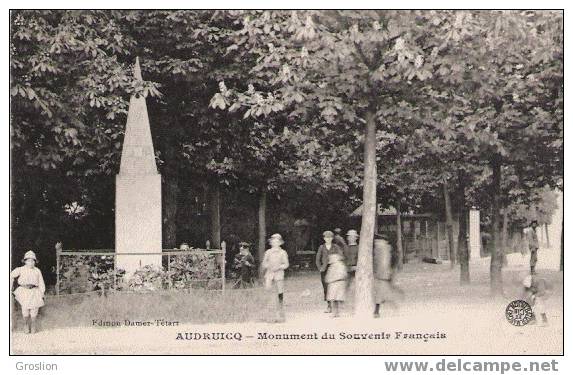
top-left (11, 253), bottom-right (563, 355)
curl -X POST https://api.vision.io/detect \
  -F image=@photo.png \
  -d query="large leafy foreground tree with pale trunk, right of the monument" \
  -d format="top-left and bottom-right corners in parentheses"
top-left (214, 11), bottom-right (460, 315)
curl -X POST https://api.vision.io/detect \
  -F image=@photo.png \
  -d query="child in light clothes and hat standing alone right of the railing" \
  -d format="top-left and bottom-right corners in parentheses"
top-left (261, 233), bottom-right (289, 322)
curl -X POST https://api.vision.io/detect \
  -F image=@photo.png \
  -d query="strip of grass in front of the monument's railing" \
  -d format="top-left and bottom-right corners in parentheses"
top-left (14, 289), bottom-right (269, 329)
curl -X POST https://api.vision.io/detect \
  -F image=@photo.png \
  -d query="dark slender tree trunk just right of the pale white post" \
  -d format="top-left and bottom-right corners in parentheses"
top-left (490, 155), bottom-right (503, 295)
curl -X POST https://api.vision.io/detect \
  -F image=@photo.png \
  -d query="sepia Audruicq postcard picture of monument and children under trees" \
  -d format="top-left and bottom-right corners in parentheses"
top-left (8, 9), bottom-right (564, 356)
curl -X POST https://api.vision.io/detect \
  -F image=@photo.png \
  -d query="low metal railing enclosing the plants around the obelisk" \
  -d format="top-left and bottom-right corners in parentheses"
top-left (56, 247), bottom-right (226, 296)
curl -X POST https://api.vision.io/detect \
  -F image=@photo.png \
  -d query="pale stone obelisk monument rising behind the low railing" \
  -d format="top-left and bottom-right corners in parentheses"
top-left (115, 58), bottom-right (162, 275)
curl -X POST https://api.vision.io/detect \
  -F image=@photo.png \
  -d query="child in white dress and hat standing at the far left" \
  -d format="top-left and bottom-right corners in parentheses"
top-left (10, 250), bottom-right (46, 333)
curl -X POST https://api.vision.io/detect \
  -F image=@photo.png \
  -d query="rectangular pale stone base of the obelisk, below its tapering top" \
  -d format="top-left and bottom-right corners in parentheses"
top-left (115, 173), bottom-right (162, 275)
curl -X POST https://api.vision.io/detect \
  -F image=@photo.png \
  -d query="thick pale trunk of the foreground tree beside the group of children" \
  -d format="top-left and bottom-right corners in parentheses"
top-left (355, 110), bottom-right (376, 317)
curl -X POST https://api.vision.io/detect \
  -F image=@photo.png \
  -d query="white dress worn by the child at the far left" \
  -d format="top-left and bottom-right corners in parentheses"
top-left (10, 266), bottom-right (46, 310)
